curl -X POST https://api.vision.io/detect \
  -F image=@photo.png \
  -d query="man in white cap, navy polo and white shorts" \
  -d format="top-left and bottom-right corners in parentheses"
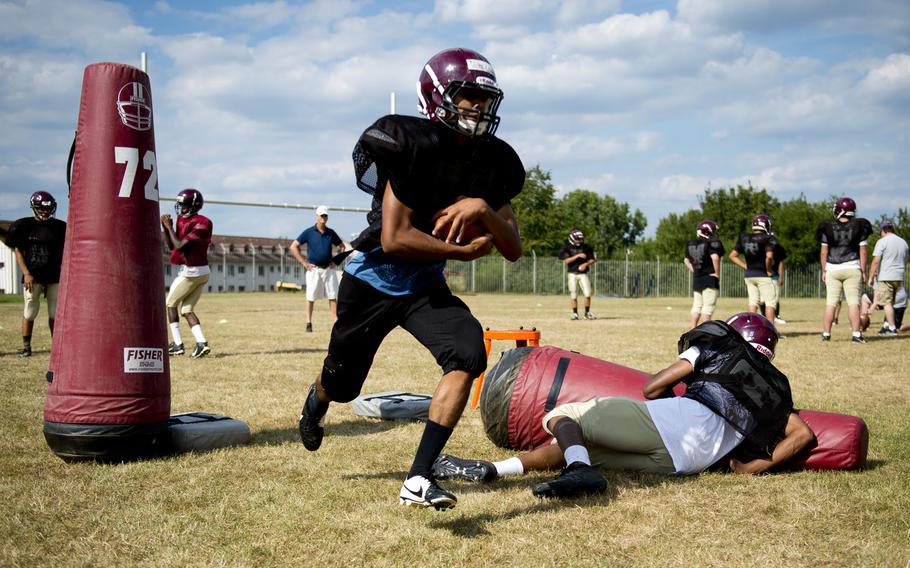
top-left (291, 205), bottom-right (345, 332)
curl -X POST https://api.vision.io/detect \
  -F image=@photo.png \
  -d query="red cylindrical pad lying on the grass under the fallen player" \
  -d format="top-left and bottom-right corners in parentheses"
top-left (480, 346), bottom-right (869, 470)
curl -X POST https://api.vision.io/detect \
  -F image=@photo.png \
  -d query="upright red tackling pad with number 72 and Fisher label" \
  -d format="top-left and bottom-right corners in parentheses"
top-left (44, 63), bottom-right (170, 460)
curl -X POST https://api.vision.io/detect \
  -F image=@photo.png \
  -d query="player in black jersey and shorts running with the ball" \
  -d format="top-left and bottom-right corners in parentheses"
top-left (299, 48), bottom-right (525, 510)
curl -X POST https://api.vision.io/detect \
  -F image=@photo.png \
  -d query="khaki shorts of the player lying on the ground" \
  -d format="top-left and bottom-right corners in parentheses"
top-left (543, 397), bottom-right (676, 474)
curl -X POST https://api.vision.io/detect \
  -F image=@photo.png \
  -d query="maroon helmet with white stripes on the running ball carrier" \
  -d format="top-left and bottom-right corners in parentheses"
top-left (417, 47), bottom-right (502, 136)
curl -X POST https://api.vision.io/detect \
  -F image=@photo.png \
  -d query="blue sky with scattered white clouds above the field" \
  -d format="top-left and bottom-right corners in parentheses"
top-left (0, 0), bottom-right (910, 242)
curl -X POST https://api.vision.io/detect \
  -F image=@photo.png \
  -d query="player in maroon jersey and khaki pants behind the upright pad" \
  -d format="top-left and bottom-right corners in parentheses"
top-left (161, 189), bottom-right (212, 359)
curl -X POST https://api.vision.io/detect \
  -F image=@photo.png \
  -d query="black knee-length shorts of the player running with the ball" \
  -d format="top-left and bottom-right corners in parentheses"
top-left (322, 274), bottom-right (487, 398)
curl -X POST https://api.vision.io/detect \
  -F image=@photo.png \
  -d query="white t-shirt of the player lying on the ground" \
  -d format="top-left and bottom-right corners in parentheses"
top-left (645, 347), bottom-right (743, 475)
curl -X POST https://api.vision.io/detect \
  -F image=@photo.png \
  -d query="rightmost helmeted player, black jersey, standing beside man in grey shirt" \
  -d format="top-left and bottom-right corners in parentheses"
top-left (815, 197), bottom-right (872, 343)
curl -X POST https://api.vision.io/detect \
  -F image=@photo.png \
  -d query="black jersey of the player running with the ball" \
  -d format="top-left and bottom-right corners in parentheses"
top-left (353, 115), bottom-right (525, 250)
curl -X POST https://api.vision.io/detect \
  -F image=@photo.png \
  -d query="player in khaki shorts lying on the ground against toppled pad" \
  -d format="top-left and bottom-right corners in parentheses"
top-left (433, 312), bottom-right (815, 497)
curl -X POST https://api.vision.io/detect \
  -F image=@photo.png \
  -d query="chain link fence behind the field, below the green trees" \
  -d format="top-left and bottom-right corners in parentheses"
top-left (446, 256), bottom-right (906, 298)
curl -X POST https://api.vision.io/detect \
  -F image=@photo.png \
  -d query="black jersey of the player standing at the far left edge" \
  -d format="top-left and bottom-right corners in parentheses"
top-left (6, 217), bottom-right (66, 284)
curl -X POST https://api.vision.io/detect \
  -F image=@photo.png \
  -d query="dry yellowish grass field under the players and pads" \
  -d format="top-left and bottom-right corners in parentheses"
top-left (0, 294), bottom-right (910, 567)
